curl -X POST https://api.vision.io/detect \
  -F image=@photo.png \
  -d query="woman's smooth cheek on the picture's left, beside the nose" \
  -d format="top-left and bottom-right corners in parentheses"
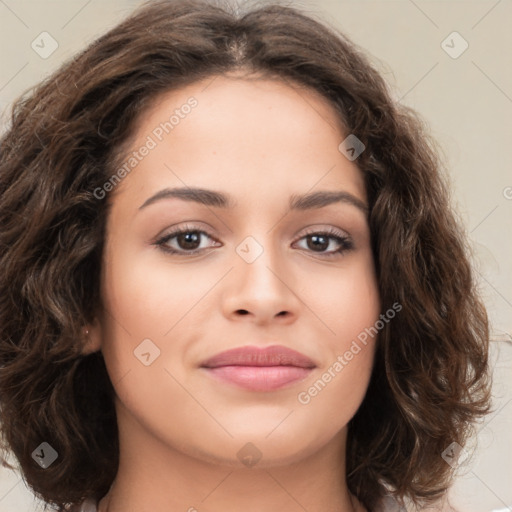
top-left (102, 244), bottom-right (197, 428)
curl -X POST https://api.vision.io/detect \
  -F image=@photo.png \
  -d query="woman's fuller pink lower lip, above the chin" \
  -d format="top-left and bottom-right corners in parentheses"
top-left (205, 366), bottom-right (312, 391)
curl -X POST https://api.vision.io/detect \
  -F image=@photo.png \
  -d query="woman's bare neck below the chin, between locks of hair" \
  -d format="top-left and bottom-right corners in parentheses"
top-left (98, 400), bottom-right (364, 512)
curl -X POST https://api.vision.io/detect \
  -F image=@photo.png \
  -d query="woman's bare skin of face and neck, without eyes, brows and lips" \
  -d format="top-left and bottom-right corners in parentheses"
top-left (87, 76), bottom-right (380, 512)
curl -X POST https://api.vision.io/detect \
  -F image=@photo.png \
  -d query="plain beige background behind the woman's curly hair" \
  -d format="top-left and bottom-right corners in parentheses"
top-left (0, 0), bottom-right (512, 512)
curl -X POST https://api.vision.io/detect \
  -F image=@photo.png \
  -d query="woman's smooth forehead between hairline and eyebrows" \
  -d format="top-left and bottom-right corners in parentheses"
top-left (108, 76), bottom-right (365, 211)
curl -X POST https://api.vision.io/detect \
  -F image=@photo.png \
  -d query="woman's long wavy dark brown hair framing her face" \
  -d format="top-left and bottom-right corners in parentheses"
top-left (0, 0), bottom-right (490, 510)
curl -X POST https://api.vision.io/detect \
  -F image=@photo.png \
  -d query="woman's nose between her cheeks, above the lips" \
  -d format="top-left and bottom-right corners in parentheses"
top-left (222, 238), bottom-right (301, 325)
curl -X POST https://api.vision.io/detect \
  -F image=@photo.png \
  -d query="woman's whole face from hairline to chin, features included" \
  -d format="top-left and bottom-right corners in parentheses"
top-left (93, 77), bottom-right (380, 467)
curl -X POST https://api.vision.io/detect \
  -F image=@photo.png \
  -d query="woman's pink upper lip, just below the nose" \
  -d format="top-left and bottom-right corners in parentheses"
top-left (201, 345), bottom-right (316, 368)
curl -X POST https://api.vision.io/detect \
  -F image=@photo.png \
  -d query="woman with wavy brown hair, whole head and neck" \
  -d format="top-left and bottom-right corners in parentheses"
top-left (0, 0), bottom-right (489, 512)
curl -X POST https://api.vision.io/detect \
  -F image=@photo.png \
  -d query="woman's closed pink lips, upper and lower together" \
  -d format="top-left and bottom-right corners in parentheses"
top-left (201, 345), bottom-right (316, 391)
